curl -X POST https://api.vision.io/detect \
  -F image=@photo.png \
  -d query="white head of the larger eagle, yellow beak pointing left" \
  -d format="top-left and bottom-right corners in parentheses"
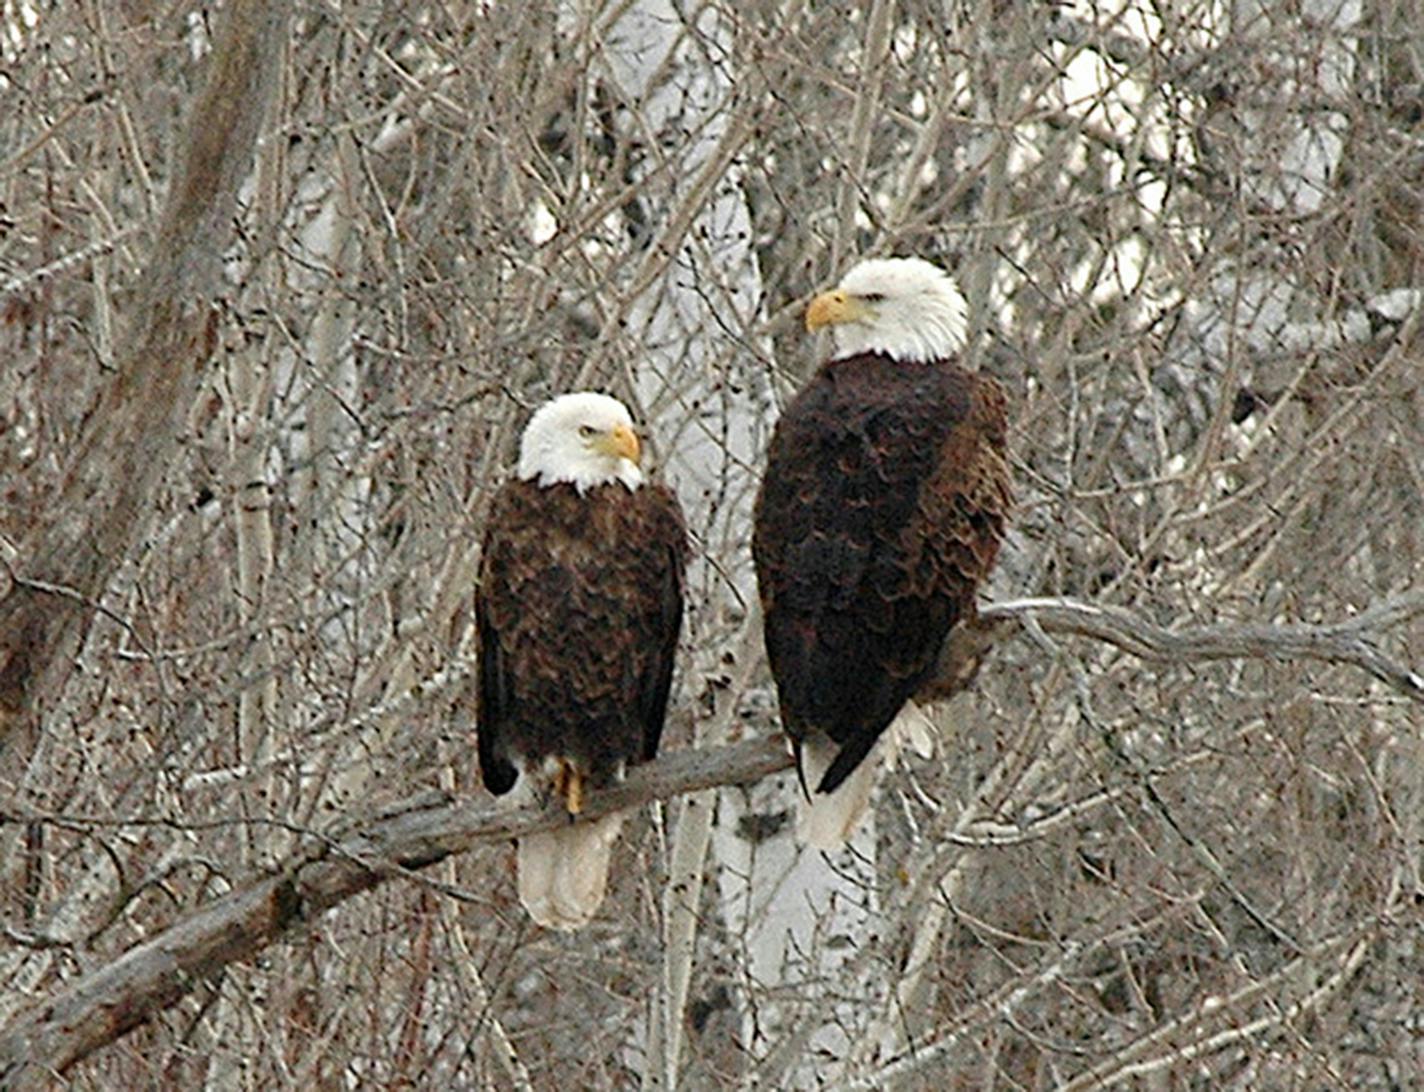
top-left (806, 258), bottom-right (965, 362)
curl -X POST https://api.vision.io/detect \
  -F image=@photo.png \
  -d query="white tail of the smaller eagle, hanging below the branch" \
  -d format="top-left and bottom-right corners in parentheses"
top-left (518, 812), bottom-right (622, 930)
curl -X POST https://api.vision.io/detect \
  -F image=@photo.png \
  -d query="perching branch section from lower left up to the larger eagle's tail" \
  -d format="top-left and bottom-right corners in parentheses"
top-left (0, 739), bottom-right (792, 1089)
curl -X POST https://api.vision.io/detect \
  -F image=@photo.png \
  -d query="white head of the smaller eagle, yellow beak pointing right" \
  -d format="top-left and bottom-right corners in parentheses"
top-left (518, 390), bottom-right (642, 493)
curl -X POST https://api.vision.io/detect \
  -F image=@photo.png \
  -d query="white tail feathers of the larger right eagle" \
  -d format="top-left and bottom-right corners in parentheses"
top-left (796, 702), bottom-right (934, 851)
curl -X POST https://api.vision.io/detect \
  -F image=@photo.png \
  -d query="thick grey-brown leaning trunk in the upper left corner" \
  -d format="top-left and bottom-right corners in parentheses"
top-left (0, 0), bottom-right (289, 733)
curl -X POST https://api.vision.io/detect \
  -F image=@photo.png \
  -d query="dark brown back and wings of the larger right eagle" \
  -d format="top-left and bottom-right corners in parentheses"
top-left (752, 355), bottom-right (1008, 792)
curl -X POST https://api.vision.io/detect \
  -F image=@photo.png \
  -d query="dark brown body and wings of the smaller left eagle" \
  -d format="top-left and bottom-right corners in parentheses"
top-left (476, 481), bottom-right (686, 793)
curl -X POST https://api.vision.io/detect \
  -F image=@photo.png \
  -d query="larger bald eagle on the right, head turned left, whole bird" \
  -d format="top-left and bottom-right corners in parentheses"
top-left (752, 258), bottom-right (1011, 849)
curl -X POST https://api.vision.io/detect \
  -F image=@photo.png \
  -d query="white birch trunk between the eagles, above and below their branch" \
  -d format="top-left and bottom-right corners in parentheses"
top-left (583, 0), bottom-right (876, 1088)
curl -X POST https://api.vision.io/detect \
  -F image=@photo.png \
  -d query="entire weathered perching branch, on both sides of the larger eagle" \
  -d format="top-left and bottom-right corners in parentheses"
top-left (0, 592), bottom-right (1424, 1088)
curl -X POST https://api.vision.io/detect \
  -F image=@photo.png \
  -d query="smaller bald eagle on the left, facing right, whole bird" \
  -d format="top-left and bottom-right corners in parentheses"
top-left (476, 392), bottom-right (688, 930)
